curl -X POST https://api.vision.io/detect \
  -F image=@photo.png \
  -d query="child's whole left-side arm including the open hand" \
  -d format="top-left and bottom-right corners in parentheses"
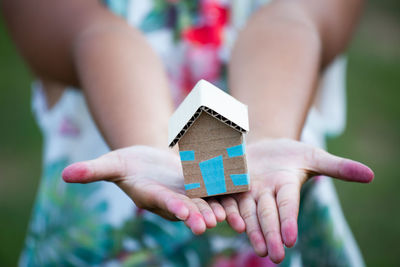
top-left (1, 0), bottom-right (225, 233)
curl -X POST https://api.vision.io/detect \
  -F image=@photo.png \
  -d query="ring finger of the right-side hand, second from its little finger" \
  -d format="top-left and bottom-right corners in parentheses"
top-left (238, 194), bottom-right (268, 257)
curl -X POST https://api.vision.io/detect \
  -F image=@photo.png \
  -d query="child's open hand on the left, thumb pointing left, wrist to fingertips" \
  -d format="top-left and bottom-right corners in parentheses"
top-left (62, 146), bottom-right (225, 234)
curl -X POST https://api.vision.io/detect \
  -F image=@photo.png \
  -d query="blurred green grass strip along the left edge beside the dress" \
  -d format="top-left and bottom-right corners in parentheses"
top-left (0, 13), bottom-right (41, 266)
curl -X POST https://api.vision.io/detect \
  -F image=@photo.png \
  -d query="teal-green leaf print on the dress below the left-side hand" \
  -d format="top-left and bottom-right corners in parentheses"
top-left (22, 159), bottom-right (216, 266)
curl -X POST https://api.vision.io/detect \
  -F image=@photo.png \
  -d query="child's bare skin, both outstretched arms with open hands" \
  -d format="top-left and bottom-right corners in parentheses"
top-left (1, 0), bottom-right (373, 263)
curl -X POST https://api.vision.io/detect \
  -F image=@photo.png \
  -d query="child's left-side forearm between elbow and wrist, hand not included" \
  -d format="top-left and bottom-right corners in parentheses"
top-left (73, 20), bottom-right (172, 148)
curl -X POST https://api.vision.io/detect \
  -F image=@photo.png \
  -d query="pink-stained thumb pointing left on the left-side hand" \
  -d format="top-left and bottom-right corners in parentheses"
top-left (62, 151), bottom-right (125, 183)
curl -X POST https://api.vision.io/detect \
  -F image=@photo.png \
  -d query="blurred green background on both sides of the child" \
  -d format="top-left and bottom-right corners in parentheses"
top-left (0, 0), bottom-right (400, 266)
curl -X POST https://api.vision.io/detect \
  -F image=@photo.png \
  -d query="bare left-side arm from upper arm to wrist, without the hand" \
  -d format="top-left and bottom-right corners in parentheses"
top-left (2, 0), bottom-right (172, 149)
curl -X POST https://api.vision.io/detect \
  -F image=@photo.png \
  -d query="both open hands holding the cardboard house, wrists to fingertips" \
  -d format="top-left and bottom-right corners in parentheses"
top-left (63, 139), bottom-right (373, 262)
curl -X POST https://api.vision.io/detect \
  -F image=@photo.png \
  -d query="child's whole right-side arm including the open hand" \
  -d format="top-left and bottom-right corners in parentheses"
top-left (222, 0), bottom-right (373, 262)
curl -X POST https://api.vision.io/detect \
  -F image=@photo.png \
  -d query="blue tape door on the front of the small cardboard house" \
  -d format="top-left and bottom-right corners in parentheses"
top-left (199, 156), bottom-right (226, 196)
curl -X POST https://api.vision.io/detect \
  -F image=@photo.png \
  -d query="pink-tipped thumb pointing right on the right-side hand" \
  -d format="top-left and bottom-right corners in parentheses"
top-left (309, 148), bottom-right (374, 183)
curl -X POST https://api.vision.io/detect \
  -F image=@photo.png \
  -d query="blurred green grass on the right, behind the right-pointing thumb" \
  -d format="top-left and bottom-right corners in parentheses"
top-left (329, 6), bottom-right (400, 266)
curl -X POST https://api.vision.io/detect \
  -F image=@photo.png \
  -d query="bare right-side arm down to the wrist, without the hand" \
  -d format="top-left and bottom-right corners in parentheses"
top-left (229, 1), bottom-right (364, 140)
